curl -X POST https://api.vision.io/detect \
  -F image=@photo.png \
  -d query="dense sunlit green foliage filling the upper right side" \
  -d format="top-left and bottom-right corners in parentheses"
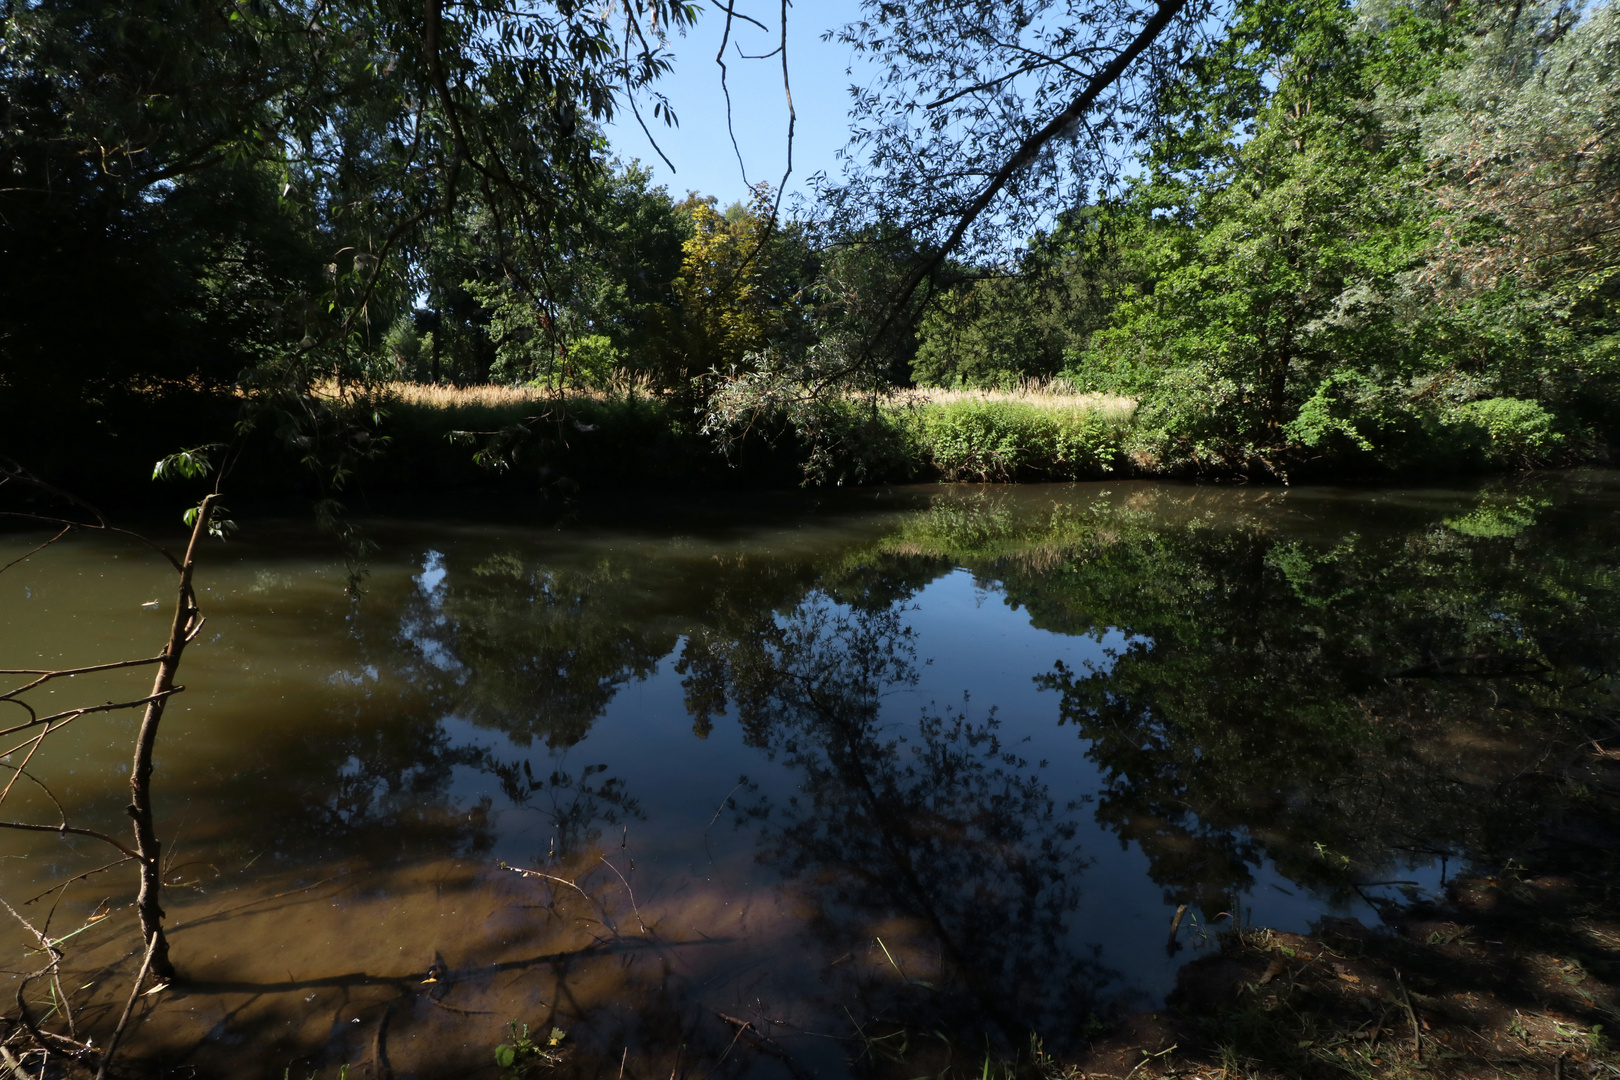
top-left (920, 2), bottom-right (1620, 476)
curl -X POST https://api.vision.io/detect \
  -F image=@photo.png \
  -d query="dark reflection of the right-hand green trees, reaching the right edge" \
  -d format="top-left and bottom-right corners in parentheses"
top-left (891, 481), bottom-right (1620, 939)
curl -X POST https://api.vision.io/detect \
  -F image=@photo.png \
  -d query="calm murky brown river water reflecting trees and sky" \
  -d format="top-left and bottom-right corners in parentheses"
top-left (0, 471), bottom-right (1620, 1077)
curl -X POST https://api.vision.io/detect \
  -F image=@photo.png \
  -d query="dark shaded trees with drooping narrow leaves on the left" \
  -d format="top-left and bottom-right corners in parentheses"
top-left (0, 0), bottom-right (695, 481)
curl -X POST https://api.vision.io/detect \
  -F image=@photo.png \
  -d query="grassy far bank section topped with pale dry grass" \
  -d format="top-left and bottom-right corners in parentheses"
top-left (370, 384), bottom-right (1142, 484)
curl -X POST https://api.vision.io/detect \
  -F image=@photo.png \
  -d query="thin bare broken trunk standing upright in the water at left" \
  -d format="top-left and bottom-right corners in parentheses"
top-left (130, 495), bottom-right (215, 980)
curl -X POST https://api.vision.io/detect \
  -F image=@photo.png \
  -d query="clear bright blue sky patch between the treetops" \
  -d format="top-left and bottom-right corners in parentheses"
top-left (608, 0), bottom-right (860, 206)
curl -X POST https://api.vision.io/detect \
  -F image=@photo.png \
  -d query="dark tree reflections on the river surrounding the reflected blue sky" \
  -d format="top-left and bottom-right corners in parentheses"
top-left (234, 479), bottom-right (1620, 1062)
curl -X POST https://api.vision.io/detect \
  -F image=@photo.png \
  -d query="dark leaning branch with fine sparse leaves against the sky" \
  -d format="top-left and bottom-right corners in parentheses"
top-left (708, 0), bottom-right (1210, 456)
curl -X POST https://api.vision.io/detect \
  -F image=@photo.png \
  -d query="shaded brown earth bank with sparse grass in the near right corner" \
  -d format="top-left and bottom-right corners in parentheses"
top-left (754, 725), bottom-right (1620, 1080)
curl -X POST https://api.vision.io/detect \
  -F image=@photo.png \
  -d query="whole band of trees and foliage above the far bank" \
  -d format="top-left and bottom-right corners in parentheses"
top-left (0, 0), bottom-right (1620, 494)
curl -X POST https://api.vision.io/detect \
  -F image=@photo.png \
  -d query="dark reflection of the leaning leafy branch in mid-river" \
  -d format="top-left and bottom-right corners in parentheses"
top-left (682, 589), bottom-right (1108, 1046)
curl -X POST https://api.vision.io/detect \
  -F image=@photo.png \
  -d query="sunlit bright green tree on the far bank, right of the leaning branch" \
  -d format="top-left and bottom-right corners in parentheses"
top-left (1072, 0), bottom-right (1483, 473)
